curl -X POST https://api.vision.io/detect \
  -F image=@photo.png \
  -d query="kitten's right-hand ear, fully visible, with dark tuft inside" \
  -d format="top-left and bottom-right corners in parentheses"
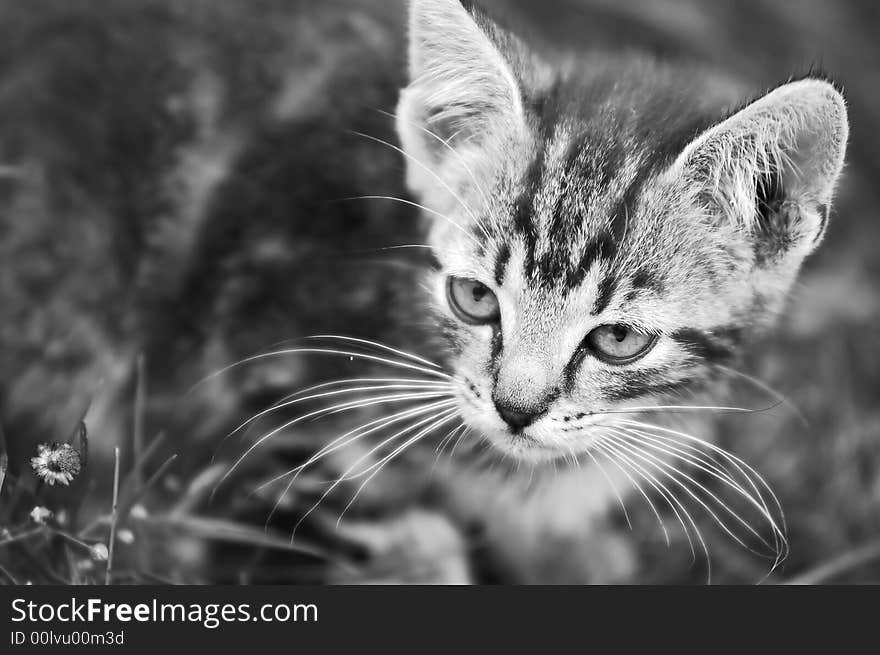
top-left (673, 79), bottom-right (849, 264)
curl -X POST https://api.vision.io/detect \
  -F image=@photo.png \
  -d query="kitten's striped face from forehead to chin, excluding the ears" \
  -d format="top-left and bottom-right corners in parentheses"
top-left (424, 124), bottom-right (753, 459)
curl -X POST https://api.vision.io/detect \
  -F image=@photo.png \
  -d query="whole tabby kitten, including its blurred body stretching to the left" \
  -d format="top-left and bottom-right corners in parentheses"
top-left (0, 0), bottom-right (847, 582)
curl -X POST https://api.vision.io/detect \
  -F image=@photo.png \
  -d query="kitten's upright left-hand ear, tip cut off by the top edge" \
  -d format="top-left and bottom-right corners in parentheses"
top-left (397, 0), bottom-right (524, 200)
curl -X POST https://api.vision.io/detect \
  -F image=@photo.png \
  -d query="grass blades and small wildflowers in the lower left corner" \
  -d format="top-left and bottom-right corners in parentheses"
top-left (0, 358), bottom-right (338, 584)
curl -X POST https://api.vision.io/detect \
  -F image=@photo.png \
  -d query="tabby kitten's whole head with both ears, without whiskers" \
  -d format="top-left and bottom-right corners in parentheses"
top-left (398, 0), bottom-right (848, 460)
